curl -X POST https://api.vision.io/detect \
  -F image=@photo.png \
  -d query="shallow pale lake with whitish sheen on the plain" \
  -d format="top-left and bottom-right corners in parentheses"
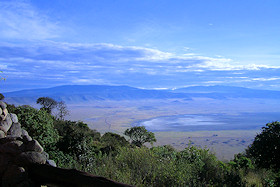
top-left (138, 113), bottom-right (280, 131)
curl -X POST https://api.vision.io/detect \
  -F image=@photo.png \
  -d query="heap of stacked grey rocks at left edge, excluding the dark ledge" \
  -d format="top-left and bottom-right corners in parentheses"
top-left (0, 101), bottom-right (55, 187)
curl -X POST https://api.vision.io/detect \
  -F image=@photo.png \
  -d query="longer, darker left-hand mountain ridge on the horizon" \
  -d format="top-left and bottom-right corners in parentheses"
top-left (4, 85), bottom-right (190, 102)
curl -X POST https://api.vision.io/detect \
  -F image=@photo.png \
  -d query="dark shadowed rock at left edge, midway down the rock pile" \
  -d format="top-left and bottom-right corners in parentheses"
top-left (0, 140), bottom-right (24, 155)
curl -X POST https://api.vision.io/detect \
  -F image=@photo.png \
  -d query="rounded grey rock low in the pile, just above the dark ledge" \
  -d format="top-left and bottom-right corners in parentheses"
top-left (15, 151), bottom-right (47, 167)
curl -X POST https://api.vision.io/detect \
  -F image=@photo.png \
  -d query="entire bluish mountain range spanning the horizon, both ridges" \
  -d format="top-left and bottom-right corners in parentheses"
top-left (3, 85), bottom-right (280, 104)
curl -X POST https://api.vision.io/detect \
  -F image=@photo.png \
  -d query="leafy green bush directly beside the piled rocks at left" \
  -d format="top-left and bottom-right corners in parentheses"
top-left (8, 105), bottom-right (59, 150)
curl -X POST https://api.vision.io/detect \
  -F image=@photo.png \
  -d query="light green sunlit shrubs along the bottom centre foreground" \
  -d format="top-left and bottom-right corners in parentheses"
top-left (85, 146), bottom-right (242, 186)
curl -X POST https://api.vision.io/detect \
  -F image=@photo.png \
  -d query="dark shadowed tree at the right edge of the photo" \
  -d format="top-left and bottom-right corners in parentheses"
top-left (247, 121), bottom-right (280, 171)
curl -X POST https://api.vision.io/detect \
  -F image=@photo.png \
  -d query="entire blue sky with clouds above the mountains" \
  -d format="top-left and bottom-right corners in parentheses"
top-left (0, 0), bottom-right (280, 92)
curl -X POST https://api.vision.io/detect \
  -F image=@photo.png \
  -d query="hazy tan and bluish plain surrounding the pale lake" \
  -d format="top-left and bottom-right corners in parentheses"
top-left (68, 98), bottom-right (280, 160)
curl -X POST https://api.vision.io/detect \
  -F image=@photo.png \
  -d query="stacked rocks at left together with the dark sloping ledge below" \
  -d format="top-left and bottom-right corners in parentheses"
top-left (0, 101), bottom-right (129, 187)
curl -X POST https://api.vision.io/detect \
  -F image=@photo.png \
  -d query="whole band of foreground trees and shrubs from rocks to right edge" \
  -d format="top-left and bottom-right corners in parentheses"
top-left (4, 97), bottom-right (280, 186)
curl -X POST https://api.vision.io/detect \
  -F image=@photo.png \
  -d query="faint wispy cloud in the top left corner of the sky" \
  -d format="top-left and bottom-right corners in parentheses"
top-left (0, 1), bottom-right (60, 40)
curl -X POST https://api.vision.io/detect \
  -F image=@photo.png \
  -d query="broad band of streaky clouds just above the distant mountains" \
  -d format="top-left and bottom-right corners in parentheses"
top-left (0, 41), bottom-right (280, 90)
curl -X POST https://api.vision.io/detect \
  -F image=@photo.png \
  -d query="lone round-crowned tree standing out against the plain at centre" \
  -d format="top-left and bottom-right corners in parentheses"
top-left (124, 126), bottom-right (157, 147)
